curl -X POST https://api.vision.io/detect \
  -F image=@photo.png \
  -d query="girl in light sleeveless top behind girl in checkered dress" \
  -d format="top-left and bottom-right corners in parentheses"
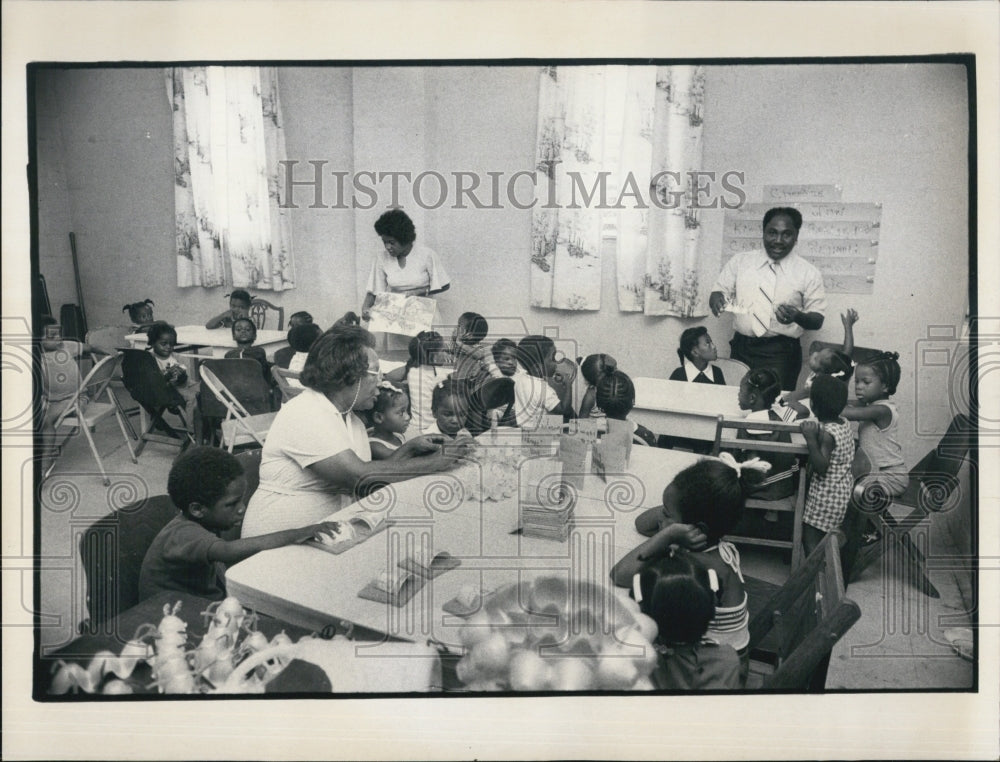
top-left (841, 352), bottom-right (910, 544)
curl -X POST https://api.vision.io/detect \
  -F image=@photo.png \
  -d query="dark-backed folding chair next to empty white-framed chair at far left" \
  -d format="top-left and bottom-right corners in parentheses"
top-left (122, 349), bottom-right (194, 457)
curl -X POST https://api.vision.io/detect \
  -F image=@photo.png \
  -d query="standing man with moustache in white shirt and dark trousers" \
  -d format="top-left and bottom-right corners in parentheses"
top-left (709, 207), bottom-right (826, 390)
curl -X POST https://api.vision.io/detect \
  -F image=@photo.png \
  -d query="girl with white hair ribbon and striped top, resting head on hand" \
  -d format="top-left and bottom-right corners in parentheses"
top-left (611, 452), bottom-right (769, 679)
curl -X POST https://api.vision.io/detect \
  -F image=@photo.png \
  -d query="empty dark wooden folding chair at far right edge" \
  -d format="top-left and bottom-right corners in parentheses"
top-left (844, 415), bottom-right (977, 598)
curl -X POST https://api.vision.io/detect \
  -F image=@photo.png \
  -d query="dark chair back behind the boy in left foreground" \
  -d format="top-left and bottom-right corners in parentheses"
top-left (78, 495), bottom-right (177, 637)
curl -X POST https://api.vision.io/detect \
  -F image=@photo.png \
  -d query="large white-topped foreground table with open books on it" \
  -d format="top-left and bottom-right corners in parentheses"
top-left (226, 447), bottom-right (698, 646)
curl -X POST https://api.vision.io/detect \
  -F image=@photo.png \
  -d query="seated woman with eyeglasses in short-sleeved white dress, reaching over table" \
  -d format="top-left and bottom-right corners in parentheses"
top-left (241, 327), bottom-right (461, 537)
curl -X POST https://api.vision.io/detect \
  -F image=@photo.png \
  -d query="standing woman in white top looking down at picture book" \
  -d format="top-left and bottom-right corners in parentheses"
top-left (361, 209), bottom-right (451, 320)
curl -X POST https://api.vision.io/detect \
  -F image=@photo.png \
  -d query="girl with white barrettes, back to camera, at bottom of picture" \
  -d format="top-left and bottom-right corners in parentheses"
top-left (631, 550), bottom-right (742, 691)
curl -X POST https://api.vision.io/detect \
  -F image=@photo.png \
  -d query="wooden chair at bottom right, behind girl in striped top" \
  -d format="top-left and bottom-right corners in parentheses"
top-left (747, 534), bottom-right (861, 691)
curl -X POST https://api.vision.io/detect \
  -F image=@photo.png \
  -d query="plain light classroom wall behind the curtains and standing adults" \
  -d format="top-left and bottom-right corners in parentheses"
top-left (37, 64), bottom-right (968, 463)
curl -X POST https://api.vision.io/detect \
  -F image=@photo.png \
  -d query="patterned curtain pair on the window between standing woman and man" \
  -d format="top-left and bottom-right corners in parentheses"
top-left (531, 66), bottom-right (711, 317)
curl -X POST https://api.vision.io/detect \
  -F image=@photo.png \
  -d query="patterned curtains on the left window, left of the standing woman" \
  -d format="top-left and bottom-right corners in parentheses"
top-left (166, 66), bottom-right (295, 291)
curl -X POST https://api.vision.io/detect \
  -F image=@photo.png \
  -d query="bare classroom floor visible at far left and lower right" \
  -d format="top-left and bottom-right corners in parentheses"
top-left (33, 420), bottom-right (974, 690)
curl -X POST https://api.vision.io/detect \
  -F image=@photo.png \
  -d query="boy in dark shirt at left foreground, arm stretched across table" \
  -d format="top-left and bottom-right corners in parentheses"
top-left (139, 447), bottom-right (339, 600)
